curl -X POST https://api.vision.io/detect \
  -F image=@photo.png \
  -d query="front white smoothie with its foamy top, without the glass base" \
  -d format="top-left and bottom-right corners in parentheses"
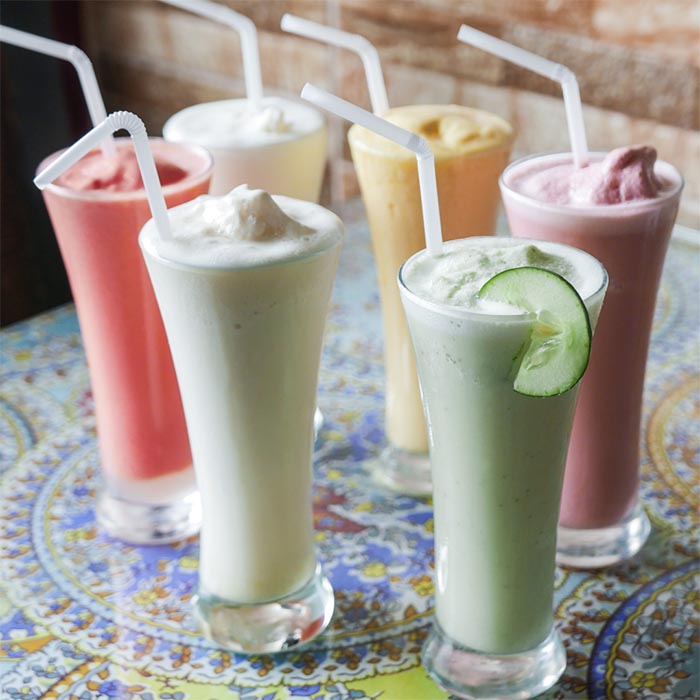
top-left (140, 186), bottom-right (343, 604)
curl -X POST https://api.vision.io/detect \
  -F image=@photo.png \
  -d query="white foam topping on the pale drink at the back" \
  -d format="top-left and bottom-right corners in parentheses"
top-left (163, 97), bottom-right (324, 148)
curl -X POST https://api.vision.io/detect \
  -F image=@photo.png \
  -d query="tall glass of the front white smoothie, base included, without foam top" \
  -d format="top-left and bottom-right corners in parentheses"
top-left (141, 205), bottom-right (340, 653)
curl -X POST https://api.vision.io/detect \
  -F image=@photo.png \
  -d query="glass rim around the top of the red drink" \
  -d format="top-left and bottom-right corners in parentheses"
top-left (36, 136), bottom-right (214, 202)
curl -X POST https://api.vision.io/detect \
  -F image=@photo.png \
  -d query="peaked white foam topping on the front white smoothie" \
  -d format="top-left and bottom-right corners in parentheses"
top-left (140, 185), bottom-right (343, 268)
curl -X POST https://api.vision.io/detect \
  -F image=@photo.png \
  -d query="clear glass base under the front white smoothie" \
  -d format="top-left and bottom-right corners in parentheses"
top-left (193, 566), bottom-right (335, 654)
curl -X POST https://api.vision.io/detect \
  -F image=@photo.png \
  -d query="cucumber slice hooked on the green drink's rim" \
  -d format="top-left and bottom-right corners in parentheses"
top-left (479, 267), bottom-right (592, 396)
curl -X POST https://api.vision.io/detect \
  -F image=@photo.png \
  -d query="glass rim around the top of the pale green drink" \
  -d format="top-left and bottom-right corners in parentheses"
top-left (397, 236), bottom-right (609, 323)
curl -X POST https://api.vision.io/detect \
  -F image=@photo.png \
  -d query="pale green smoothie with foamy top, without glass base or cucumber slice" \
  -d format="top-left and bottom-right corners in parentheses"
top-left (399, 237), bottom-right (607, 654)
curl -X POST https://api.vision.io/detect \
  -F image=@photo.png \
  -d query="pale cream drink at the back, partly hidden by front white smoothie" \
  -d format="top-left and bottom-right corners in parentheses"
top-left (163, 97), bottom-right (328, 202)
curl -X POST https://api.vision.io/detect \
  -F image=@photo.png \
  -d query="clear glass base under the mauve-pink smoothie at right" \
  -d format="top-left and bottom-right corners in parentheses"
top-left (557, 504), bottom-right (651, 569)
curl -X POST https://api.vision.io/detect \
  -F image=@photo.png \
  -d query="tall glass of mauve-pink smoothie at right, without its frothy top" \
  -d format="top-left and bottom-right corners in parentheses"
top-left (501, 153), bottom-right (683, 568)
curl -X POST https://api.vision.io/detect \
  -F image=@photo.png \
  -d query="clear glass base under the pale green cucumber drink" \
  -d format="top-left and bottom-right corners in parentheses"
top-left (421, 623), bottom-right (566, 700)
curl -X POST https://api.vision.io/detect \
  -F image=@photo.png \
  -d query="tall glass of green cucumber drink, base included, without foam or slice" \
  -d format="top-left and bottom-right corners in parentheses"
top-left (399, 238), bottom-right (607, 698)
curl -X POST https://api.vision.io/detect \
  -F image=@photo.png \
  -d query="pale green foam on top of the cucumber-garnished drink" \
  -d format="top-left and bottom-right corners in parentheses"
top-left (401, 237), bottom-right (603, 315)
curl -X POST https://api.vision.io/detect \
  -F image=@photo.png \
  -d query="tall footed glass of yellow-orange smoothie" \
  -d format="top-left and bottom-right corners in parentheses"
top-left (348, 105), bottom-right (513, 495)
